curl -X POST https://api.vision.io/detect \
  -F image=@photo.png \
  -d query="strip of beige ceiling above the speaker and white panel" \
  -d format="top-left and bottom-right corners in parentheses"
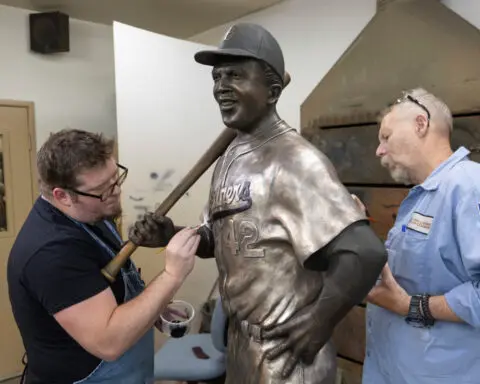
top-left (0, 0), bottom-right (282, 39)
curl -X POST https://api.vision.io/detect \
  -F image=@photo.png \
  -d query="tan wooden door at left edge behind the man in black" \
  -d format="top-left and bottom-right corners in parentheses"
top-left (0, 100), bottom-right (38, 381)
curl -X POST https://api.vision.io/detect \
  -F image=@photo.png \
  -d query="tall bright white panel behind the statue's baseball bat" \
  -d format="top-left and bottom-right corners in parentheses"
top-left (114, 23), bottom-right (223, 318)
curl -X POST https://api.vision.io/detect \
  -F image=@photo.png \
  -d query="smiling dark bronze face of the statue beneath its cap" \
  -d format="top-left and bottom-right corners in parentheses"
top-left (212, 60), bottom-right (271, 132)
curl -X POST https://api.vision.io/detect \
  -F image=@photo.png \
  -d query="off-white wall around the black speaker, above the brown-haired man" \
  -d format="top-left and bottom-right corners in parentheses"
top-left (0, 6), bottom-right (116, 148)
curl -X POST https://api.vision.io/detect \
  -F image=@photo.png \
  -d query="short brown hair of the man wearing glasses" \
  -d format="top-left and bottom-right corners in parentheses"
top-left (37, 129), bottom-right (114, 194)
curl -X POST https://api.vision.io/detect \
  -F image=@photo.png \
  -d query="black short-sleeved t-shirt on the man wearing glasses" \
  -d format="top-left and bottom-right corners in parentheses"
top-left (7, 198), bottom-right (125, 384)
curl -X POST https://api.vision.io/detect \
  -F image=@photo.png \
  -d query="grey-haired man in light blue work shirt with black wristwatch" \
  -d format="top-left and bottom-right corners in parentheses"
top-left (363, 89), bottom-right (480, 384)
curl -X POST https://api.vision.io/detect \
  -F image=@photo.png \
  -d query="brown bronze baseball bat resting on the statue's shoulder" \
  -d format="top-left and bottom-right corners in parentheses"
top-left (102, 72), bottom-right (291, 283)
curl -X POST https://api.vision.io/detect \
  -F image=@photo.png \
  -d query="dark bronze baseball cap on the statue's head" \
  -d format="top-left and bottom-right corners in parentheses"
top-left (194, 23), bottom-right (285, 84)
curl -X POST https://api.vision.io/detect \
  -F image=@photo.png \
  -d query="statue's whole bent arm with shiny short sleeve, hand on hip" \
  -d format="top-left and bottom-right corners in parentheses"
top-left (262, 145), bottom-right (387, 377)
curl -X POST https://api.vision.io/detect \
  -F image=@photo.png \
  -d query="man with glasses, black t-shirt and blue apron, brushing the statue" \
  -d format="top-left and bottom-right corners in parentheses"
top-left (7, 130), bottom-right (200, 384)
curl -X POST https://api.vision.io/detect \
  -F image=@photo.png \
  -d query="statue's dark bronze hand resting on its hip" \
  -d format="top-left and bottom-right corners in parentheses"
top-left (262, 303), bottom-right (333, 378)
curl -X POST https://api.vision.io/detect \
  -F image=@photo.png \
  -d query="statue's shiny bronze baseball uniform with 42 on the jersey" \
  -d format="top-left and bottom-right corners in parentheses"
top-left (202, 121), bottom-right (365, 384)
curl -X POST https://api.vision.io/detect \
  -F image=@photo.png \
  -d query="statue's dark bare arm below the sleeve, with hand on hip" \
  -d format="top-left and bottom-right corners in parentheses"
top-left (263, 214), bottom-right (387, 378)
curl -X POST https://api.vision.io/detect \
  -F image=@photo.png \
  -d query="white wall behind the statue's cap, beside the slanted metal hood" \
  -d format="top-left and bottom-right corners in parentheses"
top-left (189, 0), bottom-right (480, 129)
